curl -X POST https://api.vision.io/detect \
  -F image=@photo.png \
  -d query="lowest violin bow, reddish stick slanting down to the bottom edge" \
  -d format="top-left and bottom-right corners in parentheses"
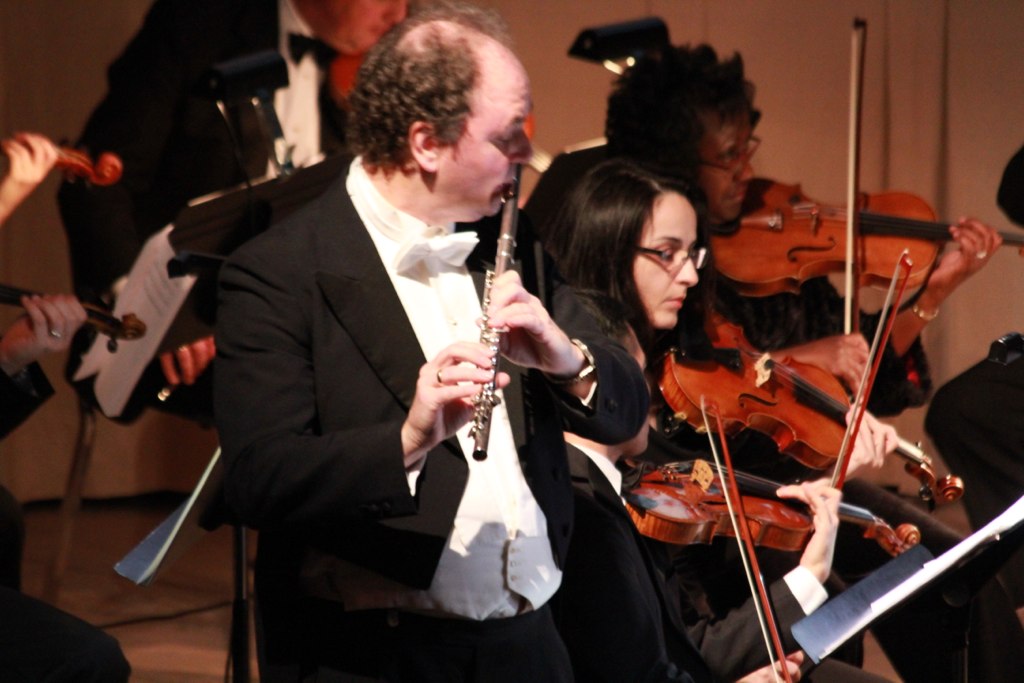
top-left (700, 395), bottom-right (793, 683)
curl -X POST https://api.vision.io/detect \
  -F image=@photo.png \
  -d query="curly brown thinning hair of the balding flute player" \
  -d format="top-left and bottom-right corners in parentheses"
top-left (347, 2), bottom-right (511, 170)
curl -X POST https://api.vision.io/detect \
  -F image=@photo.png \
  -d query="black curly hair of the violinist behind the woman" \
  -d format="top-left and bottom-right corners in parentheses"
top-left (604, 45), bottom-right (760, 182)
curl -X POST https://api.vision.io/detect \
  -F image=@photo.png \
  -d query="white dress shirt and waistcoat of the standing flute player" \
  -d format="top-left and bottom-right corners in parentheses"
top-left (319, 159), bottom-right (561, 620)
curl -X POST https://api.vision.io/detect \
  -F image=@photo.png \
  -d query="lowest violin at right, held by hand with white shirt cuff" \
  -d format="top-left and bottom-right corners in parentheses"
top-left (626, 461), bottom-right (921, 557)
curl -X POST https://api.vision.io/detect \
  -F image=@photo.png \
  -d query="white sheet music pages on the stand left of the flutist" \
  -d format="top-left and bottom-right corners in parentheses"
top-left (75, 224), bottom-right (196, 418)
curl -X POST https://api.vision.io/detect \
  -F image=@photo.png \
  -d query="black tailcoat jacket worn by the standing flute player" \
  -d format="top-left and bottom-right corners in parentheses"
top-left (214, 163), bottom-right (647, 593)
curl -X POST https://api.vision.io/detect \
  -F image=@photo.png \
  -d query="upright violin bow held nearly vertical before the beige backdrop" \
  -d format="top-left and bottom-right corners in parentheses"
top-left (843, 18), bottom-right (867, 334)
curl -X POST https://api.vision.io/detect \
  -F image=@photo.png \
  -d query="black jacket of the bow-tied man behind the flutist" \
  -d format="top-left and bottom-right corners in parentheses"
top-left (58, 0), bottom-right (344, 296)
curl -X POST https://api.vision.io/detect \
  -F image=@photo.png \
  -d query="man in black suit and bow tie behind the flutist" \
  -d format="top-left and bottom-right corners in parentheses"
top-left (58, 0), bottom-right (409, 420)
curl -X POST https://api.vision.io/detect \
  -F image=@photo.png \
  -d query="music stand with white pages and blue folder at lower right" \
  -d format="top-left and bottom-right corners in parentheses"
top-left (792, 497), bottom-right (1024, 681)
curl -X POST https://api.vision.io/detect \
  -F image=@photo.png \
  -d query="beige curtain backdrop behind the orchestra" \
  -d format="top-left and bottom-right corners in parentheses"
top-left (0, 0), bottom-right (1024, 500)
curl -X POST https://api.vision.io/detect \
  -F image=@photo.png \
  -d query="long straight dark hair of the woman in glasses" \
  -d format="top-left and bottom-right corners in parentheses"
top-left (546, 159), bottom-right (705, 351)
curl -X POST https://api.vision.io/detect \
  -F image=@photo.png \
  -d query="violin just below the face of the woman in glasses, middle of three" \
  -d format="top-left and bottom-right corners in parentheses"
top-left (658, 316), bottom-right (964, 505)
